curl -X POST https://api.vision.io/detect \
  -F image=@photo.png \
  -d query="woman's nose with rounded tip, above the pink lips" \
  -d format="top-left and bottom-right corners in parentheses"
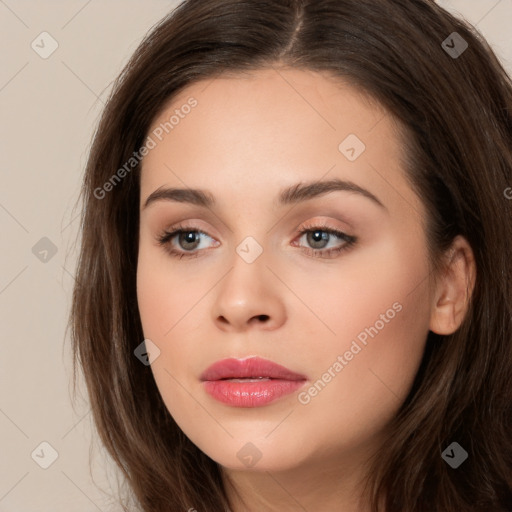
top-left (213, 254), bottom-right (286, 332)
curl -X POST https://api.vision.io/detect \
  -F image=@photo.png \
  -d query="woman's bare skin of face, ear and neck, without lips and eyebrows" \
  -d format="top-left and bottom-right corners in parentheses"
top-left (137, 68), bottom-right (474, 512)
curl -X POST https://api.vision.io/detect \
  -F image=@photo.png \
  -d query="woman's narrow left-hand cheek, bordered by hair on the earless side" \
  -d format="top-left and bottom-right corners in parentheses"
top-left (137, 246), bottom-right (213, 436)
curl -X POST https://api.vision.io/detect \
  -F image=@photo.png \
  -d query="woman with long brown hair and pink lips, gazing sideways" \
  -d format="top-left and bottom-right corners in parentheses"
top-left (70, 0), bottom-right (512, 512)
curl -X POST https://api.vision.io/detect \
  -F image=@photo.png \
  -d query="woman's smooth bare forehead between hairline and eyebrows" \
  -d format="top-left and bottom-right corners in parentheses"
top-left (141, 68), bottom-right (420, 218)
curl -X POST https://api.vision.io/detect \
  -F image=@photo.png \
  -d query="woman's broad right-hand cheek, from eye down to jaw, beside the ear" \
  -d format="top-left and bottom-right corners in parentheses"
top-left (292, 238), bottom-right (430, 442)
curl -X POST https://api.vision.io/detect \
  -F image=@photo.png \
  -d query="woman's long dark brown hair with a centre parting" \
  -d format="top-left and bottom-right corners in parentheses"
top-left (70, 0), bottom-right (512, 512)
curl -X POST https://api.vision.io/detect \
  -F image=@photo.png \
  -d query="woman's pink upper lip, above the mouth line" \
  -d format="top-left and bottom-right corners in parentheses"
top-left (200, 357), bottom-right (306, 381)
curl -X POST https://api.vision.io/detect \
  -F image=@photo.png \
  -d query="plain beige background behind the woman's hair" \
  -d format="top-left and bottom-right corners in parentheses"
top-left (0, 0), bottom-right (512, 512)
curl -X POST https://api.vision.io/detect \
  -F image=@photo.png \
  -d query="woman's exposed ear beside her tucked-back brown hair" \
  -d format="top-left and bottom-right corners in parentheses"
top-left (430, 235), bottom-right (476, 335)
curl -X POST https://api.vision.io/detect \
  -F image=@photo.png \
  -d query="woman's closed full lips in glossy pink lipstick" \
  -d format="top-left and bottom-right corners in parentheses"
top-left (200, 357), bottom-right (307, 407)
